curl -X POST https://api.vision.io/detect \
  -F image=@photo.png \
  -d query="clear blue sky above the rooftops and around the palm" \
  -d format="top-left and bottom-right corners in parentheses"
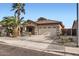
top-left (0, 3), bottom-right (76, 28)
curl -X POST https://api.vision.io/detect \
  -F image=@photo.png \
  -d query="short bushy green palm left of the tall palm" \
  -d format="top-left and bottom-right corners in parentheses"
top-left (0, 16), bottom-right (17, 36)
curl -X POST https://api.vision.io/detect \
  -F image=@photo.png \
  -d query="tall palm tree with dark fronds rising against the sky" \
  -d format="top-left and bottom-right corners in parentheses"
top-left (12, 3), bottom-right (25, 36)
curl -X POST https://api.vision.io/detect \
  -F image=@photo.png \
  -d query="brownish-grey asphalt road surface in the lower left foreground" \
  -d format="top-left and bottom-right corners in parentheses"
top-left (0, 44), bottom-right (56, 56)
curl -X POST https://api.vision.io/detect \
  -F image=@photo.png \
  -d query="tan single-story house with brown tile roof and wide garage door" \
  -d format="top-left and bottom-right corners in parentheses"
top-left (24, 17), bottom-right (64, 35)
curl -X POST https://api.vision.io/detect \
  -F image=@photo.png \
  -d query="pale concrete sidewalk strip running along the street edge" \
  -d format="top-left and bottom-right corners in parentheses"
top-left (0, 37), bottom-right (79, 55)
